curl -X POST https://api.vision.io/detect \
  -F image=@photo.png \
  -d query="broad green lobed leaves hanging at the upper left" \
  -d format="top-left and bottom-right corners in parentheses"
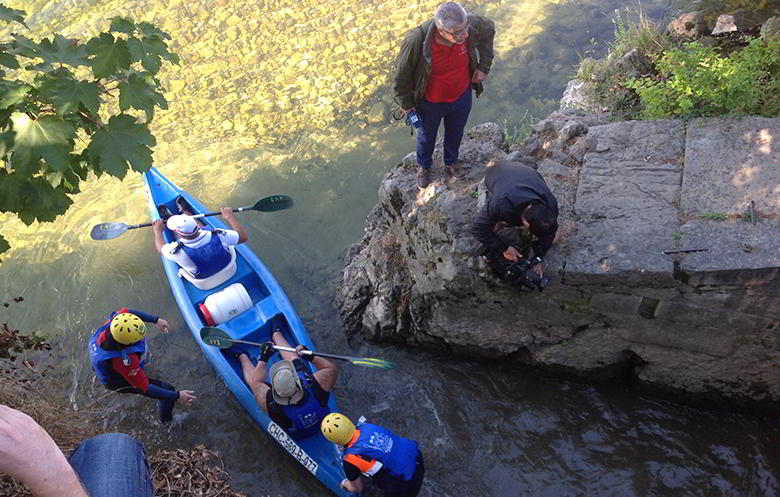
top-left (0, 4), bottom-right (179, 258)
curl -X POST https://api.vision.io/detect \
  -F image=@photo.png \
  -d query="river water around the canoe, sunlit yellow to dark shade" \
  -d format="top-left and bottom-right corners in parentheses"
top-left (0, 0), bottom-right (780, 497)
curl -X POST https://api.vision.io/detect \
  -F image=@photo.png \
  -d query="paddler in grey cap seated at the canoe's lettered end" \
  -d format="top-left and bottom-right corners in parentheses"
top-left (238, 330), bottom-right (339, 438)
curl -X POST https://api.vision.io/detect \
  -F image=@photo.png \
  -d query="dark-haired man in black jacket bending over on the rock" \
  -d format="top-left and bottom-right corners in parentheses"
top-left (471, 161), bottom-right (558, 277)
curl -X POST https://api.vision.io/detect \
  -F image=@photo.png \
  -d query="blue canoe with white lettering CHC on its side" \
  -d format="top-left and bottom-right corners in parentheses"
top-left (144, 168), bottom-right (353, 497)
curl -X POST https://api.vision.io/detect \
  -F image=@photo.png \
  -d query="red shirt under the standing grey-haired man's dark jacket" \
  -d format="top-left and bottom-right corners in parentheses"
top-left (425, 40), bottom-right (471, 103)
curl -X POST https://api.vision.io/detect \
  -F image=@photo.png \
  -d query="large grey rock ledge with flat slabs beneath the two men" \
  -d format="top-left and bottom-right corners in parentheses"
top-left (338, 117), bottom-right (780, 410)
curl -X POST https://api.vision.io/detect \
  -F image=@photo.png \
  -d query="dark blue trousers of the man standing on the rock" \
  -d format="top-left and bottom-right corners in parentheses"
top-left (416, 85), bottom-right (471, 169)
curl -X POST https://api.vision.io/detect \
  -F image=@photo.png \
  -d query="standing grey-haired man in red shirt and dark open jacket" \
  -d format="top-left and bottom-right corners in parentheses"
top-left (393, 2), bottom-right (495, 189)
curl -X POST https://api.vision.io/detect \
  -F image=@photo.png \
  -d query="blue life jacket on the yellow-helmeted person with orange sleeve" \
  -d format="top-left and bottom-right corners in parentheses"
top-left (343, 423), bottom-right (420, 481)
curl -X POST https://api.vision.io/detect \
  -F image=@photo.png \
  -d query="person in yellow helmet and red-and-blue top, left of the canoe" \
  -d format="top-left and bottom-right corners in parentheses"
top-left (89, 307), bottom-right (195, 423)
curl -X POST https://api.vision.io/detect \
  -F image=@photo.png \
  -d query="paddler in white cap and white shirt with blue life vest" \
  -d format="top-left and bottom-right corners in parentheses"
top-left (153, 202), bottom-right (249, 279)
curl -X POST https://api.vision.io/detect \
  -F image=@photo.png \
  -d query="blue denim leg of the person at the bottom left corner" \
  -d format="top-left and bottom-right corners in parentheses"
top-left (68, 433), bottom-right (154, 497)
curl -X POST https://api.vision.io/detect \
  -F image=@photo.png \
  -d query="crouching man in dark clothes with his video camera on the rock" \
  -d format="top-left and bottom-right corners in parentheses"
top-left (471, 161), bottom-right (558, 291)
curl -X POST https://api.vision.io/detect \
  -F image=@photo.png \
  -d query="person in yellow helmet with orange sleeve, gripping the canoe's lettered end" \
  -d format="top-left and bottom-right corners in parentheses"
top-left (320, 412), bottom-right (425, 497)
